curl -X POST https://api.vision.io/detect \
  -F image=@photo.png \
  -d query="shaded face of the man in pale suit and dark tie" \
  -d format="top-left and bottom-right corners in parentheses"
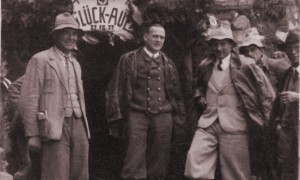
top-left (212, 39), bottom-right (233, 59)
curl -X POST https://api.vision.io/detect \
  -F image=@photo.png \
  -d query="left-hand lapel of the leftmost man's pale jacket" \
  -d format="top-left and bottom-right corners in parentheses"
top-left (48, 47), bottom-right (68, 91)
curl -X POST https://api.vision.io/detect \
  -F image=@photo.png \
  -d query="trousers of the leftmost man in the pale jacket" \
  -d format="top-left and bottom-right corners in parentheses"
top-left (41, 116), bottom-right (89, 180)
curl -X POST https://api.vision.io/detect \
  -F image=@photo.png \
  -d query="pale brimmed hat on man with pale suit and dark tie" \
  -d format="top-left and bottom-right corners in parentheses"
top-left (207, 21), bottom-right (236, 46)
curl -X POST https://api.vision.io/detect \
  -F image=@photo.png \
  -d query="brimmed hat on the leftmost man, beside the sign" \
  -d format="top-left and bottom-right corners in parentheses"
top-left (50, 12), bottom-right (84, 36)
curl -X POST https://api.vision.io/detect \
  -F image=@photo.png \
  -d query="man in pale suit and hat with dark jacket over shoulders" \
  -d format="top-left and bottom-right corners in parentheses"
top-left (185, 22), bottom-right (275, 180)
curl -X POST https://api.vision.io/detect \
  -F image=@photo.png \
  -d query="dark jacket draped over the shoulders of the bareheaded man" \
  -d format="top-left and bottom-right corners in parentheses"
top-left (106, 48), bottom-right (185, 139)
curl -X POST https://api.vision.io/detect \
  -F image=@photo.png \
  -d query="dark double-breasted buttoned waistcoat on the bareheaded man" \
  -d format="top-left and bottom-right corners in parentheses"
top-left (130, 50), bottom-right (172, 114)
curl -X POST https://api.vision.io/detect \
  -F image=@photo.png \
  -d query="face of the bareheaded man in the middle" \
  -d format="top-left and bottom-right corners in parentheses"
top-left (144, 26), bottom-right (166, 53)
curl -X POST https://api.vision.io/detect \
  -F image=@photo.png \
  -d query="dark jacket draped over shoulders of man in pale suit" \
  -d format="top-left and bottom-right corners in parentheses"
top-left (194, 52), bottom-right (275, 127)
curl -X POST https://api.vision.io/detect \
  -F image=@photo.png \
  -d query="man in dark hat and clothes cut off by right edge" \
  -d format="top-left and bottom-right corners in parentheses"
top-left (271, 29), bottom-right (300, 180)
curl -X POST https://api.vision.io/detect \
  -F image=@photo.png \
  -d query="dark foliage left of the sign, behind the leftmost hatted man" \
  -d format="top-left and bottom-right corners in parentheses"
top-left (1, 0), bottom-right (72, 80)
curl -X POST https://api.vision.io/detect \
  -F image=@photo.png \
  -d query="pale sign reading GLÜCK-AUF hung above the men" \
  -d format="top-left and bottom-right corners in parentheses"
top-left (73, 0), bottom-right (133, 32)
